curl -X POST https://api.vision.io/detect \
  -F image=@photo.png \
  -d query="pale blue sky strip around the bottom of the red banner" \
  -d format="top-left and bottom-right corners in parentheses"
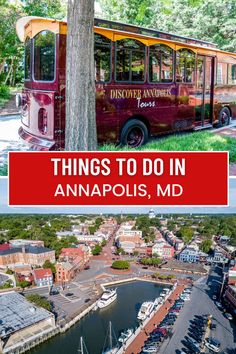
top-left (0, 178), bottom-right (236, 214)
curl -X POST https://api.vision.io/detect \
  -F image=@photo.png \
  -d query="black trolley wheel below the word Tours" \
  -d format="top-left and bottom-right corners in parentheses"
top-left (120, 119), bottom-right (148, 148)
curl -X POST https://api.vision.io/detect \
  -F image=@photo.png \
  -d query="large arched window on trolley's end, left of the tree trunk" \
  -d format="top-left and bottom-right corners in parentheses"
top-left (34, 31), bottom-right (55, 81)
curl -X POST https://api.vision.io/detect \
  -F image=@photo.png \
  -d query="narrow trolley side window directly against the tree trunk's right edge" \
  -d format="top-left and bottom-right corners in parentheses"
top-left (94, 34), bottom-right (111, 82)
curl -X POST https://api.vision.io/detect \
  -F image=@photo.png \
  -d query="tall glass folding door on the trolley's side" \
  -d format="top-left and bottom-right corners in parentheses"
top-left (195, 55), bottom-right (214, 129)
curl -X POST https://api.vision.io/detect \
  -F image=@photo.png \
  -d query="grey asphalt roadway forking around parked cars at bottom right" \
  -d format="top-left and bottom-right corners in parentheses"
top-left (156, 271), bottom-right (236, 354)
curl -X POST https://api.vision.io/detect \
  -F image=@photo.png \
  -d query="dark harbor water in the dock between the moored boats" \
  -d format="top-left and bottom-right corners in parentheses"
top-left (29, 281), bottom-right (164, 354)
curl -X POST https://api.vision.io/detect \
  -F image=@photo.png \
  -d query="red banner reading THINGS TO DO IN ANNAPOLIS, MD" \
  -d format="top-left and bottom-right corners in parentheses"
top-left (9, 152), bottom-right (228, 206)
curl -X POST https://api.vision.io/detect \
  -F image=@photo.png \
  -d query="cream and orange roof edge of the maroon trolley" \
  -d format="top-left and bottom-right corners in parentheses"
top-left (16, 16), bottom-right (236, 58)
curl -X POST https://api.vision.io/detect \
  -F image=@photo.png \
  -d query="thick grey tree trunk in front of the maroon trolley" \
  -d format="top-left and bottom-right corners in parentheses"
top-left (65, 0), bottom-right (97, 151)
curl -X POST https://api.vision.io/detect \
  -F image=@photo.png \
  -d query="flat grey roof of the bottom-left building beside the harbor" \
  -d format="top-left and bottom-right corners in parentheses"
top-left (0, 291), bottom-right (52, 338)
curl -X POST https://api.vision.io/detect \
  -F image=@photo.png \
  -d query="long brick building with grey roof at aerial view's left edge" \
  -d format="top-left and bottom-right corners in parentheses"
top-left (0, 245), bottom-right (55, 269)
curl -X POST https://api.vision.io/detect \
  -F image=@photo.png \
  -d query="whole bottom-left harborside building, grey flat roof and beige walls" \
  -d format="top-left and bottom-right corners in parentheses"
top-left (0, 291), bottom-right (56, 353)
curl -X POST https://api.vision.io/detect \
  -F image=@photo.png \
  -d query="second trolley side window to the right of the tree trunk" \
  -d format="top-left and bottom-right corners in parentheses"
top-left (116, 39), bottom-right (145, 82)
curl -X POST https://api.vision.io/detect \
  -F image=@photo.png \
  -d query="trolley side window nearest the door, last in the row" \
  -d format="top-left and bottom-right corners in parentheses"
top-left (176, 49), bottom-right (196, 83)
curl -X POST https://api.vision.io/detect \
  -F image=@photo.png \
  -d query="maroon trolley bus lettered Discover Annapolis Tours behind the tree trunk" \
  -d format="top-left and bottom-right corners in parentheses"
top-left (16, 17), bottom-right (236, 150)
